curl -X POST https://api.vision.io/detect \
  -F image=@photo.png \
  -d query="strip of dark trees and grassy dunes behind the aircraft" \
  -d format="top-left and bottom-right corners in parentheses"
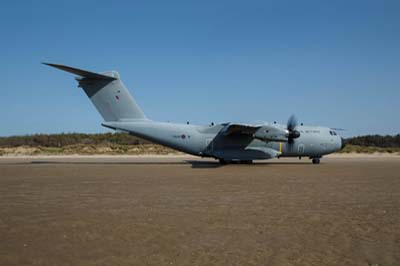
top-left (0, 133), bottom-right (400, 156)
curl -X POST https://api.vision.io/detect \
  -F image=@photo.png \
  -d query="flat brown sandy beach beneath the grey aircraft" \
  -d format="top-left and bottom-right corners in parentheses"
top-left (0, 155), bottom-right (400, 266)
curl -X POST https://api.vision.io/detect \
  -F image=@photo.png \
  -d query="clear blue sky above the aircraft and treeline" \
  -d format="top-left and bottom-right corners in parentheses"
top-left (0, 0), bottom-right (400, 136)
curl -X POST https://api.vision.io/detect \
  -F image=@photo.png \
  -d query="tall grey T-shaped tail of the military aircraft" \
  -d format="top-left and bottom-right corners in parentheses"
top-left (43, 63), bottom-right (147, 121)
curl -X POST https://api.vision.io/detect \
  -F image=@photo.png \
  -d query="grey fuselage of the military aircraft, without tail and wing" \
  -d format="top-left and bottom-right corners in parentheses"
top-left (103, 120), bottom-right (342, 160)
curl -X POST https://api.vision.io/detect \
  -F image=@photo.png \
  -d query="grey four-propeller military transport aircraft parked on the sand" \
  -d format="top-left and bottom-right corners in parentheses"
top-left (43, 63), bottom-right (344, 164)
